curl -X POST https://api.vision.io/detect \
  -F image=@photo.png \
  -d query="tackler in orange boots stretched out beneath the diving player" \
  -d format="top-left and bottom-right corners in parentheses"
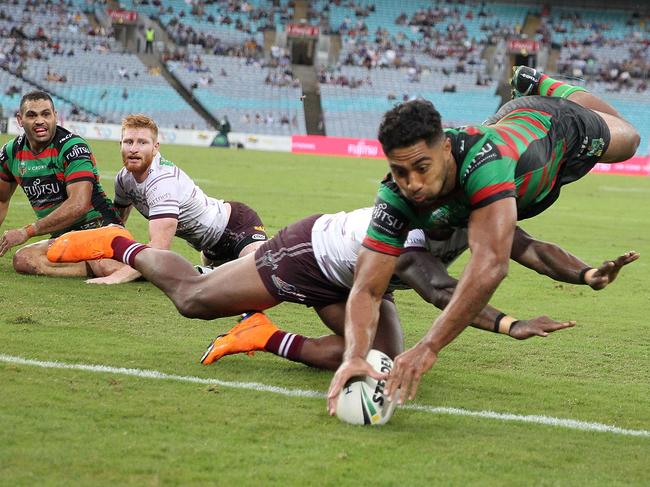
top-left (48, 208), bottom-right (626, 369)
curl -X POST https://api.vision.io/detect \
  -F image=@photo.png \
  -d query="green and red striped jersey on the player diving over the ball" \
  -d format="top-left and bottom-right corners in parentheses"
top-left (363, 103), bottom-right (568, 255)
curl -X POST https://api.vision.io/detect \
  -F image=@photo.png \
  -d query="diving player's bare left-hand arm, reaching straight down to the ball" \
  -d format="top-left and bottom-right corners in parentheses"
top-left (327, 247), bottom-right (397, 415)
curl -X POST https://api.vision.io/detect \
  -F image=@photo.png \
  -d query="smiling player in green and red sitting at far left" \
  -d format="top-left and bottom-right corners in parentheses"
top-left (0, 91), bottom-right (121, 276)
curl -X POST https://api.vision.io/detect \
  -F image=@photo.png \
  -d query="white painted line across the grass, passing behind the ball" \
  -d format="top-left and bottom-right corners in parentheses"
top-left (0, 354), bottom-right (650, 437)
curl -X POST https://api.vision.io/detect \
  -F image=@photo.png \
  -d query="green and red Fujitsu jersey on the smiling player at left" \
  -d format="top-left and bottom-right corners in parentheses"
top-left (0, 126), bottom-right (121, 235)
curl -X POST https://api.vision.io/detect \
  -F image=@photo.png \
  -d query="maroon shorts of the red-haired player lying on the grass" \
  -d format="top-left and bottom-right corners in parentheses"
top-left (203, 201), bottom-right (269, 262)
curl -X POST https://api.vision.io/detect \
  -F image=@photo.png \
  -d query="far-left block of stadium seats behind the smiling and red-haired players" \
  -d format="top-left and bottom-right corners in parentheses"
top-left (0, 2), bottom-right (207, 128)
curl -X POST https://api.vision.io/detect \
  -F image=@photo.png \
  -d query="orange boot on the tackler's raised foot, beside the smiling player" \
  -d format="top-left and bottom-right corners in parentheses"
top-left (47, 225), bottom-right (133, 262)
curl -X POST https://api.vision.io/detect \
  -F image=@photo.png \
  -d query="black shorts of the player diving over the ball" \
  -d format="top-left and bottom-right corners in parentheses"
top-left (485, 96), bottom-right (611, 220)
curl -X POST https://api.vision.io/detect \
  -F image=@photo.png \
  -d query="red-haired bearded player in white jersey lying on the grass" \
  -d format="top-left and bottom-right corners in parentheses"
top-left (87, 115), bottom-right (267, 284)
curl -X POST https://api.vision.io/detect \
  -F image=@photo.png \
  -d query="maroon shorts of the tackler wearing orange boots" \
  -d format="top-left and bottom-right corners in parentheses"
top-left (255, 215), bottom-right (350, 308)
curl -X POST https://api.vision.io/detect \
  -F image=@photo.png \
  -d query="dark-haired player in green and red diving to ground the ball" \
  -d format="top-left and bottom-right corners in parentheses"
top-left (328, 67), bottom-right (639, 414)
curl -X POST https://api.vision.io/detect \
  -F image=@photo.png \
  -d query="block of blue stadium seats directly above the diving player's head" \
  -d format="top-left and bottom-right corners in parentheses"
top-left (316, 0), bottom-right (516, 138)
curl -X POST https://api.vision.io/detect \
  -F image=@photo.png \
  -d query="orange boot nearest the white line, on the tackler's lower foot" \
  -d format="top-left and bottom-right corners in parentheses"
top-left (201, 313), bottom-right (278, 365)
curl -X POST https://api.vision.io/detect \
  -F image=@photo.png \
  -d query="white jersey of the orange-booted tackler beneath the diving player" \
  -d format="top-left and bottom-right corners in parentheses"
top-left (311, 208), bottom-right (467, 289)
